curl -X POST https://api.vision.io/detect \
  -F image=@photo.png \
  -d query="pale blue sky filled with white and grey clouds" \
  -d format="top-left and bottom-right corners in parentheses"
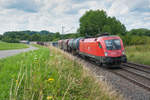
top-left (0, 0), bottom-right (150, 34)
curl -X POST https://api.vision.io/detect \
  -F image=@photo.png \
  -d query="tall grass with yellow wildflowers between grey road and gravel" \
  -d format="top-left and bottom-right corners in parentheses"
top-left (0, 47), bottom-right (122, 100)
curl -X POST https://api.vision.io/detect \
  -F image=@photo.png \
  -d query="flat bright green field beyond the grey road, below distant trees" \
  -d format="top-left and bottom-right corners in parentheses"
top-left (0, 41), bottom-right (28, 50)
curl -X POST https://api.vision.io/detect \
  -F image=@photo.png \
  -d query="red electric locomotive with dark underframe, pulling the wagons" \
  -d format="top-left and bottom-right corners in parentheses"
top-left (78, 35), bottom-right (127, 65)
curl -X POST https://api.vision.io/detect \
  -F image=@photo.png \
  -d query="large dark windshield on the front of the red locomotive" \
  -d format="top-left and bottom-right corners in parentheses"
top-left (105, 39), bottom-right (121, 50)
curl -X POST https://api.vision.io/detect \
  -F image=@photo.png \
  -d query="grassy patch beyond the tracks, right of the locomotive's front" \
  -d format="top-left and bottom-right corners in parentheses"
top-left (125, 45), bottom-right (150, 65)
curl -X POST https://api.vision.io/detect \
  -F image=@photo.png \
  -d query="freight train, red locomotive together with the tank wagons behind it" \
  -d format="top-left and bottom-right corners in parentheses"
top-left (54, 34), bottom-right (127, 66)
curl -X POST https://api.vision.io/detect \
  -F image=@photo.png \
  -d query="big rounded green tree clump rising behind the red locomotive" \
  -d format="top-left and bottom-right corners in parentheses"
top-left (78, 10), bottom-right (126, 36)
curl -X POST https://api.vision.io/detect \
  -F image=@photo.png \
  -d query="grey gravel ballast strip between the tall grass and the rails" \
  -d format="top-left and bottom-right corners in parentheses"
top-left (75, 57), bottom-right (150, 100)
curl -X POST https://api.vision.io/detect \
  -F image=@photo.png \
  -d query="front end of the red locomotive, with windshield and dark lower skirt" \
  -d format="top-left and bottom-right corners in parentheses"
top-left (102, 36), bottom-right (127, 65)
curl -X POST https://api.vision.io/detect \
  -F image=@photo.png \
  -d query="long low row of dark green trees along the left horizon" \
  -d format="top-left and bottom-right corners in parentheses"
top-left (0, 31), bottom-right (80, 43)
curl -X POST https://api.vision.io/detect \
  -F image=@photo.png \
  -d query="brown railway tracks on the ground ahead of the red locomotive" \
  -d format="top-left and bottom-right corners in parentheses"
top-left (110, 62), bottom-right (150, 91)
